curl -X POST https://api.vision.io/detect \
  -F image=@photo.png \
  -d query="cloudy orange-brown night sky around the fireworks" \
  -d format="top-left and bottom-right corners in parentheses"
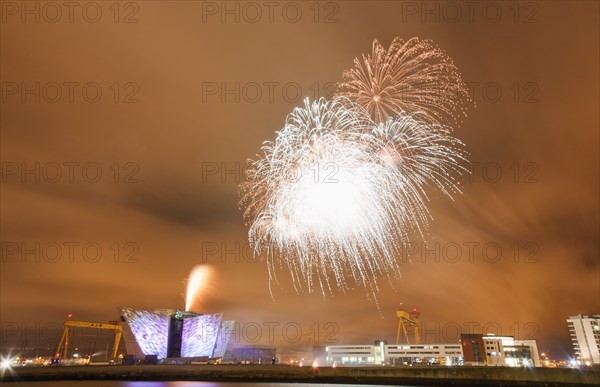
top-left (0, 1), bottom-right (600, 358)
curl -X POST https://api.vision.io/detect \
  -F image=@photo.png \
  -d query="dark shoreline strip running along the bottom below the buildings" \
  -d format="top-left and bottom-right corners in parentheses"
top-left (0, 365), bottom-right (600, 386)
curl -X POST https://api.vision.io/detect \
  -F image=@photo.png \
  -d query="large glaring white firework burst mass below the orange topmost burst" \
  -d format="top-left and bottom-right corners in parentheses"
top-left (240, 98), bottom-right (464, 296)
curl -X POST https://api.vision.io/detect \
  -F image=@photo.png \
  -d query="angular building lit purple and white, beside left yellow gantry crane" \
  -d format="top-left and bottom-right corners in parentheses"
top-left (119, 307), bottom-right (235, 359)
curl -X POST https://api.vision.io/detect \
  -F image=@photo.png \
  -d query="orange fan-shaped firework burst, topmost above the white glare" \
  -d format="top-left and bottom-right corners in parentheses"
top-left (336, 37), bottom-right (469, 126)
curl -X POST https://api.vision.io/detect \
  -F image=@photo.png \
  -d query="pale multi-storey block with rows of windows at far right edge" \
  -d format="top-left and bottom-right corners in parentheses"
top-left (567, 314), bottom-right (600, 365)
